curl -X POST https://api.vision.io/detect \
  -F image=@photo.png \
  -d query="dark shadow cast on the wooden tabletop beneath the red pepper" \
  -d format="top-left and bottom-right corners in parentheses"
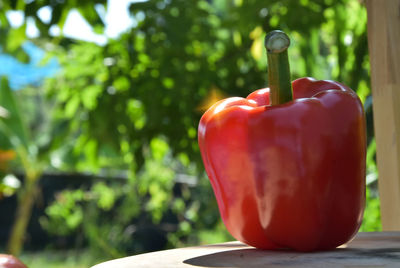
top-left (183, 247), bottom-right (400, 268)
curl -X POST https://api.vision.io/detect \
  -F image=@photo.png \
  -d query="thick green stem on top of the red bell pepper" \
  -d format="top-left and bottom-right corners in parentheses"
top-left (265, 31), bottom-right (293, 105)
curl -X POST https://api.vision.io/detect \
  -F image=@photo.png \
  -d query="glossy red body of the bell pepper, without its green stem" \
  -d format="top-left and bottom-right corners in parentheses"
top-left (198, 78), bottom-right (366, 251)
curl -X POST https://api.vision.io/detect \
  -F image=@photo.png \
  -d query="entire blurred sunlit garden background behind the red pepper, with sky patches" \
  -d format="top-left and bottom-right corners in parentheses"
top-left (0, 0), bottom-right (381, 267)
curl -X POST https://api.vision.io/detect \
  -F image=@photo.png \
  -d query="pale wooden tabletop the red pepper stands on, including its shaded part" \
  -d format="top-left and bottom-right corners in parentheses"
top-left (93, 232), bottom-right (400, 268)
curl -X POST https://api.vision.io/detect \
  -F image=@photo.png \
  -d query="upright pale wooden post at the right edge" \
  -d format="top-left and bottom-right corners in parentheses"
top-left (366, 0), bottom-right (400, 231)
